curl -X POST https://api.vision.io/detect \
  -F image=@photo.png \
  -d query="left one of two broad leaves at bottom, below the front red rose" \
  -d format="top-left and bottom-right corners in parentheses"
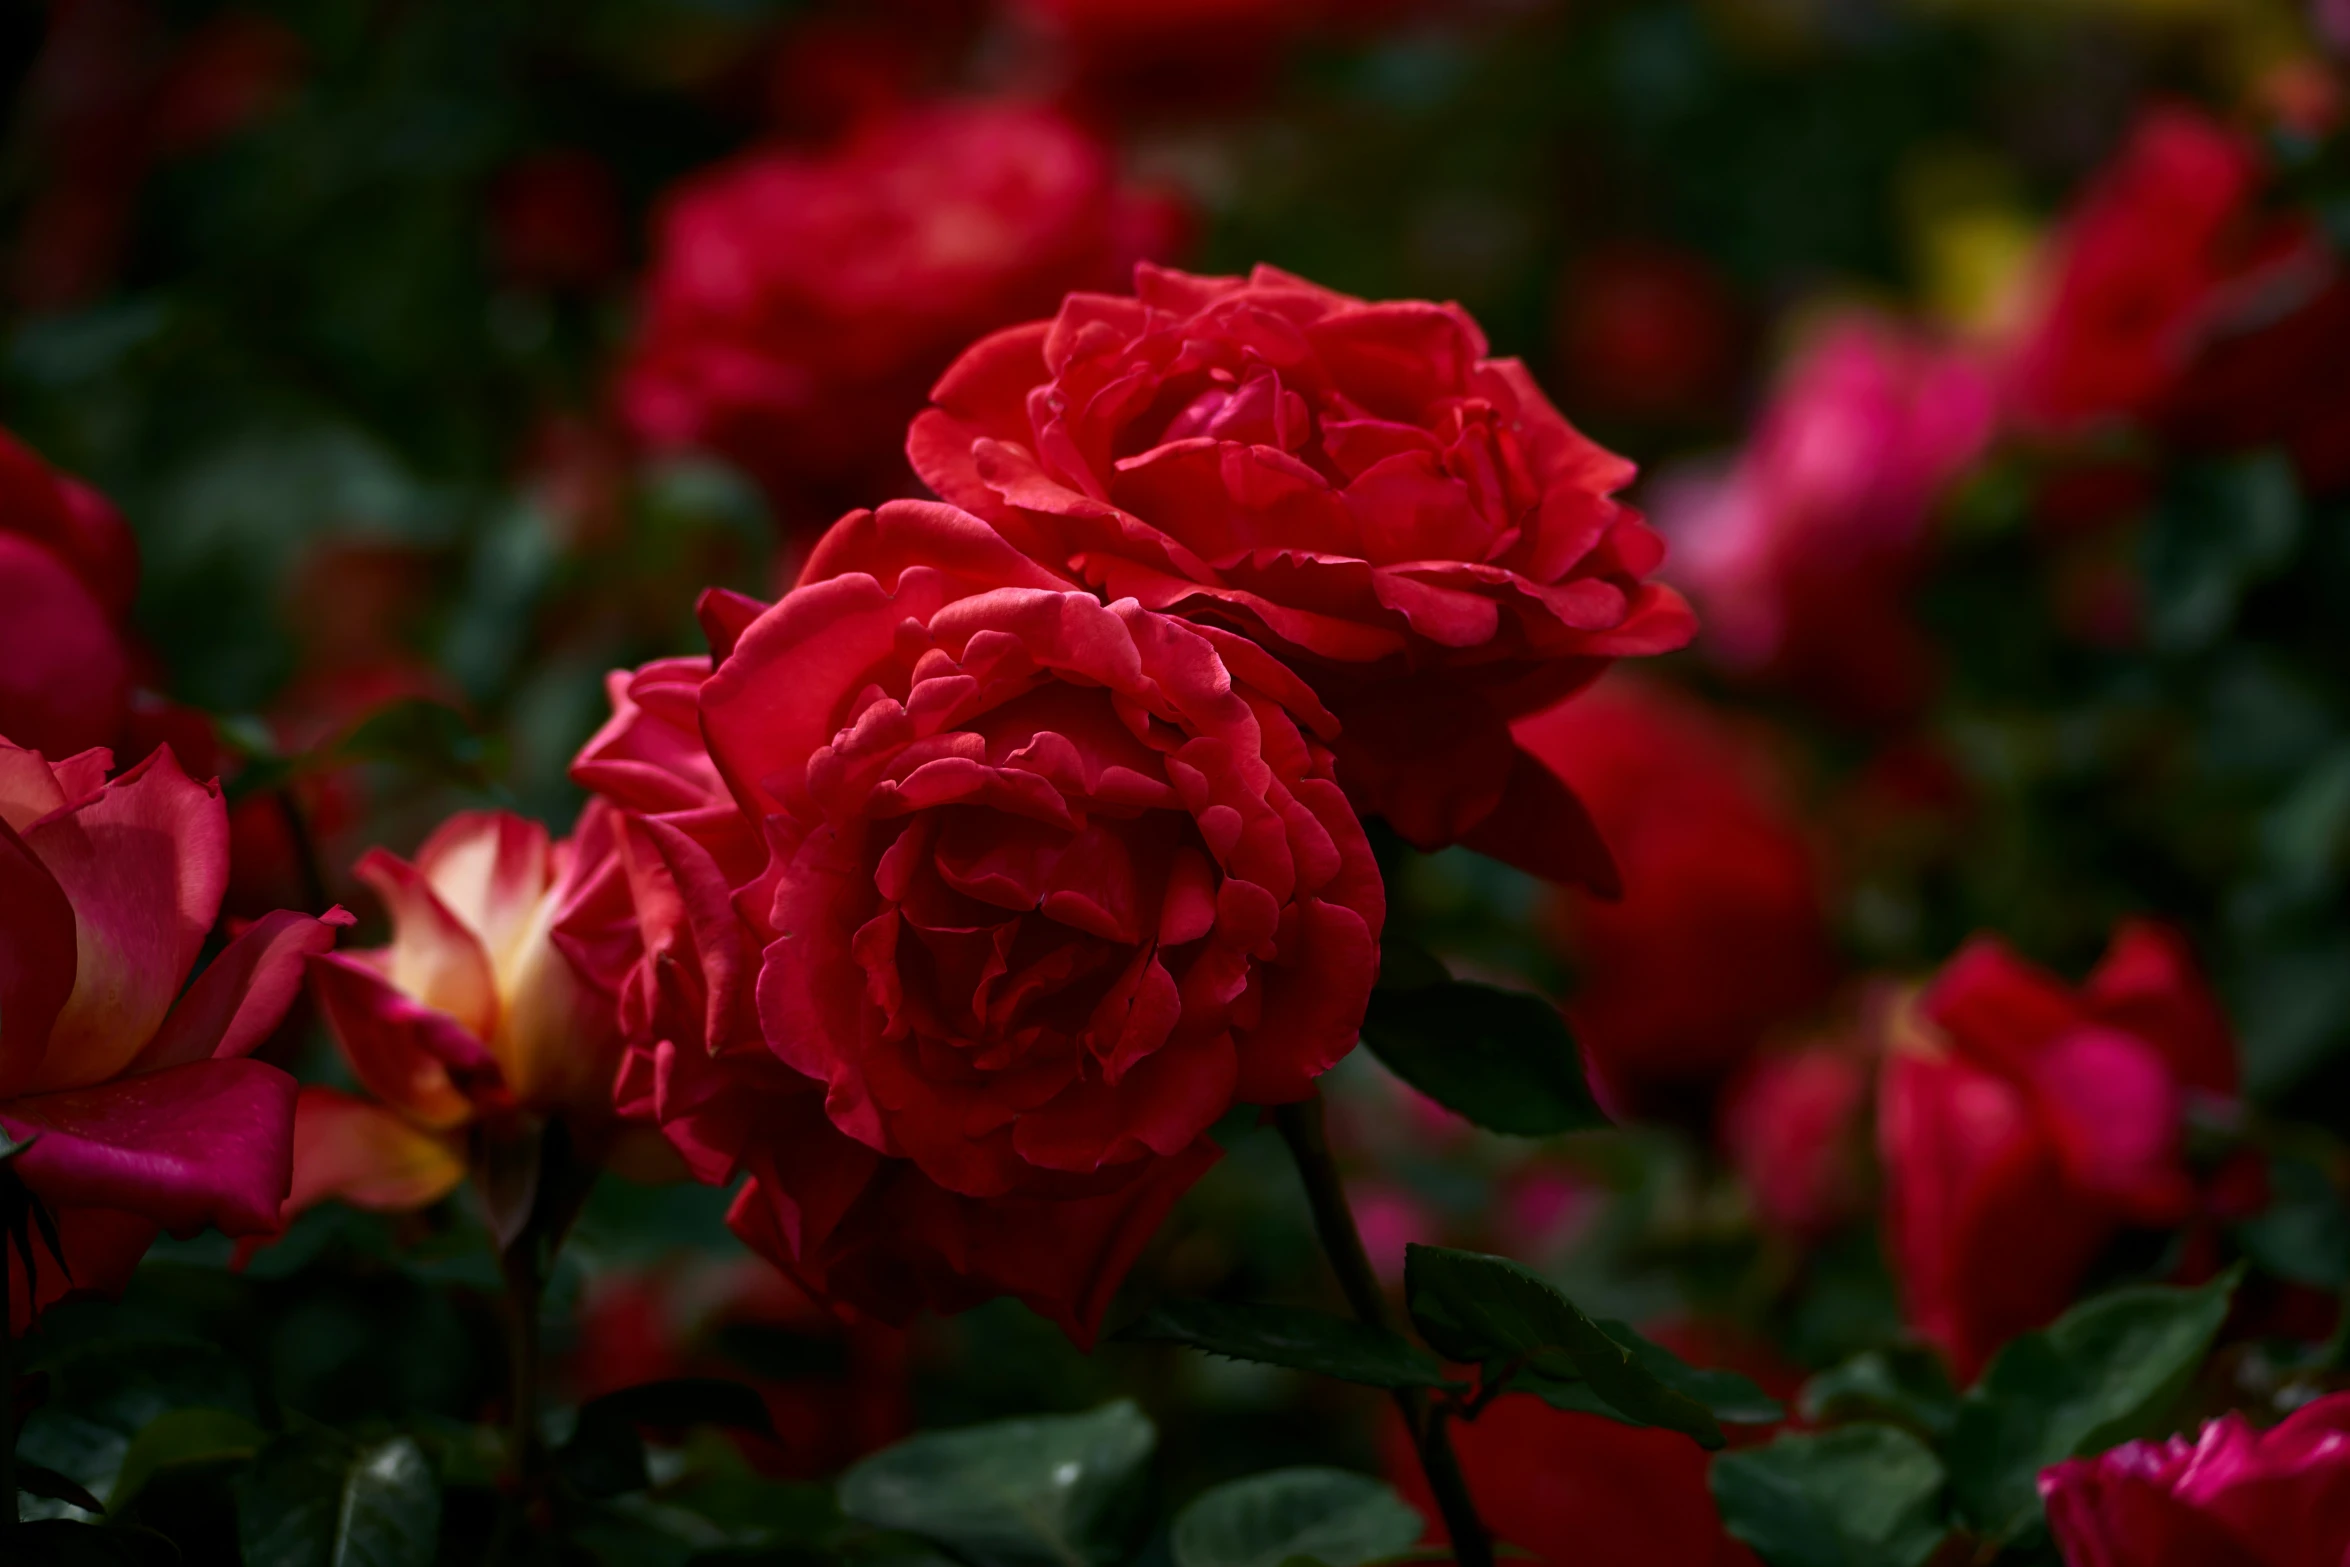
top-left (841, 1398), bottom-right (1159, 1567)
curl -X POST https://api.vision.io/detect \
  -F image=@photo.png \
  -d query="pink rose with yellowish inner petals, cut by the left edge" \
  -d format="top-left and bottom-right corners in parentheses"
top-left (0, 740), bottom-right (350, 1332)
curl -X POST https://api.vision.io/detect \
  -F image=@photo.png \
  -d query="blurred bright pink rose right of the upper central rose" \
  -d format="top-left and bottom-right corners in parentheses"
top-left (1657, 315), bottom-right (1998, 724)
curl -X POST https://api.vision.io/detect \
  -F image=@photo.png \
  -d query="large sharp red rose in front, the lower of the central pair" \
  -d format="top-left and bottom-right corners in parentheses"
top-left (576, 503), bottom-right (1384, 1339)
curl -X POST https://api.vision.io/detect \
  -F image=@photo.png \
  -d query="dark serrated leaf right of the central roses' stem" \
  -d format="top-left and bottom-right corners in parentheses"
top-left (1403, 1245), bottom-right (1723, 1447)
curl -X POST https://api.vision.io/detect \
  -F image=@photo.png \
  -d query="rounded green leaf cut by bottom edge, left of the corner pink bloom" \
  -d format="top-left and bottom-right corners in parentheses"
top-left (1713, 1424), bottom-right (1951, 1567)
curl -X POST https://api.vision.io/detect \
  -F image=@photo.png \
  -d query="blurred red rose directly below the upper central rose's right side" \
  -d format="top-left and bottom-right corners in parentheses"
top-left (1518, 681), bottom-right (1835, 1111)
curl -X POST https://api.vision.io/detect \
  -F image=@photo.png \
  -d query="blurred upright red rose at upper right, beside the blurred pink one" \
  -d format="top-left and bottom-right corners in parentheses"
top-left (2009, 108), bottom-right (2258, 432)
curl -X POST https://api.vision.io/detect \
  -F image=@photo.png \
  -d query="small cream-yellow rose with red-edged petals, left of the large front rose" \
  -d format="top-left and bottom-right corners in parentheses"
top-left (303, 811), bottom-right (620, 1215)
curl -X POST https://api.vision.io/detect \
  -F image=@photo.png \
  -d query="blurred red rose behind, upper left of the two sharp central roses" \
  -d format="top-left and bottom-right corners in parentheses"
top-left (620, 103), bottom-right (1175, 530)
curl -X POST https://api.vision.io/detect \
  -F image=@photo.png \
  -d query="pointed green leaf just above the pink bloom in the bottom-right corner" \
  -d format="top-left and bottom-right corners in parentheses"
top-left (1946, 1271), bottom-right (2240, 1541)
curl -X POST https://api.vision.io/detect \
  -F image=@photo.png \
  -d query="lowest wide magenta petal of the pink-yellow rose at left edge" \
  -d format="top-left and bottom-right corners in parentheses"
top-left (0, 1062), bottom-right (296, 1236)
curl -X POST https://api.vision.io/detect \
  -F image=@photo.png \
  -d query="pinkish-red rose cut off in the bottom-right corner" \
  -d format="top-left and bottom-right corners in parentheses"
top-left (2040, 1393), bottom-right (2350, 1567)
